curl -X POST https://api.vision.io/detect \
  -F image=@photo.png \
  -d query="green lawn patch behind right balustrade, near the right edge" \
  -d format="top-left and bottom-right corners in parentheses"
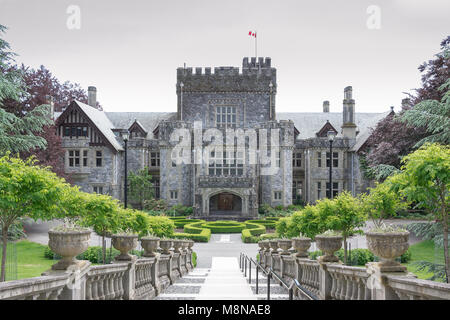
top-left (406, 240), bottom-right (444, 279)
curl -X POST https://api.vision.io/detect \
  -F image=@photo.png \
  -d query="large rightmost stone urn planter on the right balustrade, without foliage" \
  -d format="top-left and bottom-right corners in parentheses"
top-left (366, 231), bottom-right (409, 272)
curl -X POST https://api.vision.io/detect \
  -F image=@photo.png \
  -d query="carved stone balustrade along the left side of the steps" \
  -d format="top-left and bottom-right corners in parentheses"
top-left (0, 245), bottom-right (193, 300)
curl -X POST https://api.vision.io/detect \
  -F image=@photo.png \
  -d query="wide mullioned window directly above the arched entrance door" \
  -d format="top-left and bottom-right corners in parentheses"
top-left (209, 151), bottom-right (244, 176)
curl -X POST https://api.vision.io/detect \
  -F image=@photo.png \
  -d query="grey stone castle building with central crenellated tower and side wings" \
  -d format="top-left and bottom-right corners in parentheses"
top-left (55, 58), bottom-right (392, 217)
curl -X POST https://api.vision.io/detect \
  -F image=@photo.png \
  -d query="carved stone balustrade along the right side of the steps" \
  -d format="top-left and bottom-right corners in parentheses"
top-left (259, 249), bottom-right (450, 300)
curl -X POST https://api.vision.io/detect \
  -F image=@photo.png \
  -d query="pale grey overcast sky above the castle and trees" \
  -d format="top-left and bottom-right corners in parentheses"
top-left (0, 0), bottom-right (450, 112)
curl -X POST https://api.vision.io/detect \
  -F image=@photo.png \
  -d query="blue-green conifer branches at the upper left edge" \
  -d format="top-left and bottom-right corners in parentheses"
top-left (0, 25), bottom-right (52, 154)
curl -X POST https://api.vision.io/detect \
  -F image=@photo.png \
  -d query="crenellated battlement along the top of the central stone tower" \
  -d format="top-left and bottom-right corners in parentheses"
top-left (177, 58), bottom-right (276, 92)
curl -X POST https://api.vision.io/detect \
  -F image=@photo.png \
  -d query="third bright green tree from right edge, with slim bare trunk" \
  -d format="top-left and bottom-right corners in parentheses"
top-left (317, 191), bottom-right (367, 263)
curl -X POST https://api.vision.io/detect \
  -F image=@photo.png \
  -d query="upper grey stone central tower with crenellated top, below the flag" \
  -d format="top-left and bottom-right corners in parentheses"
top-left (176, 57), bottom-right (277, 127)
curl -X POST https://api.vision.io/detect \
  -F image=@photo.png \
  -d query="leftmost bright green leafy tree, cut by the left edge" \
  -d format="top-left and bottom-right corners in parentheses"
top-left (0, 153), bottom-right (70, 281)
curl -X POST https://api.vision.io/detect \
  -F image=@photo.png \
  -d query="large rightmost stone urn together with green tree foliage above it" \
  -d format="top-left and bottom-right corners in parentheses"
top-left (362, 181), bottom-right (409, 272)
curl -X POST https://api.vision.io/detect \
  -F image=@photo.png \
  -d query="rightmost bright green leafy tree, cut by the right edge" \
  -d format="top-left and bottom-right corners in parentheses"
top-left (388, 143), bottom-right (450, 283)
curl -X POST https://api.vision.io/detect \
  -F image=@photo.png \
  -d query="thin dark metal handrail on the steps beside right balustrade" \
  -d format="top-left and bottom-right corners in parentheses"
top-left (239, 253), bottom-right (319, 300)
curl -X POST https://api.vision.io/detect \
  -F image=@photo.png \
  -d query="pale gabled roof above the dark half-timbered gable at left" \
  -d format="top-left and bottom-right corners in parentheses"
top-left (57, 100), bottom-right (123, 151)
